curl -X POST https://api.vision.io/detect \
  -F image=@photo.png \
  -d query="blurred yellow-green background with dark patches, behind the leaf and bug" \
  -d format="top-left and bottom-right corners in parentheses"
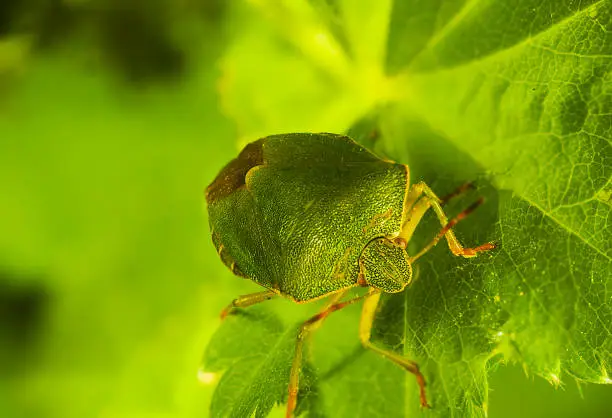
top-left (0, 0), bottom-right (612, 418)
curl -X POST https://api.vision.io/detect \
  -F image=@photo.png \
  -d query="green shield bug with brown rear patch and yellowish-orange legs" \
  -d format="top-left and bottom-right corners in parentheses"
top-left (206, 133), bottom-right (494, 417)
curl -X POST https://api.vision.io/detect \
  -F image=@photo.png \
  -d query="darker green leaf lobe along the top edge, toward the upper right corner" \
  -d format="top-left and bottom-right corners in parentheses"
top-left (388, 0), bottom-right (603, 70)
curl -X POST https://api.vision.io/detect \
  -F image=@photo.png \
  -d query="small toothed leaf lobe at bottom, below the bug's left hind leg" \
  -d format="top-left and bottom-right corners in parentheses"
top-left (203, 307), bottom-right (316, 417)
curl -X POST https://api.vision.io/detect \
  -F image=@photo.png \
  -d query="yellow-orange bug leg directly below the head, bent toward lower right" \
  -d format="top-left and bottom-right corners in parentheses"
top-left (359, 290), bottom-right (430, 408)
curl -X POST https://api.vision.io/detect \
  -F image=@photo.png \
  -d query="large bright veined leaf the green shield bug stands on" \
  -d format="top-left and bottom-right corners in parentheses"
top-left (204, 0), bottom-right (612, 417)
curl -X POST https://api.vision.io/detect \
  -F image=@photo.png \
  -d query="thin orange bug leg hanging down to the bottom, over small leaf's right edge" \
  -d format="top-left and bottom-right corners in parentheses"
top-left (286, 290), bottom-right (368, 418)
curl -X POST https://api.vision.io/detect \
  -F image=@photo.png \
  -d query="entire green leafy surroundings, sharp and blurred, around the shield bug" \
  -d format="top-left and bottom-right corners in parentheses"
top-left (0, 0), bottom-right (612, 418)
